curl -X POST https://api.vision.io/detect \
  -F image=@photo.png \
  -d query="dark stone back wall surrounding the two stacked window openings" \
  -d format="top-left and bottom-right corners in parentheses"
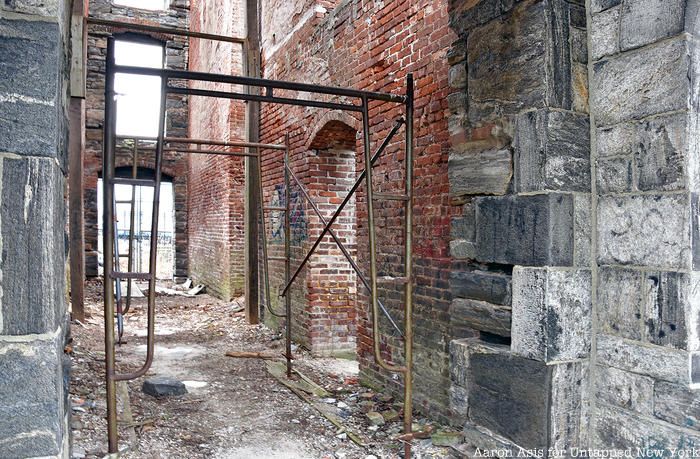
top-left (83, 0), bottom-right (189, 277)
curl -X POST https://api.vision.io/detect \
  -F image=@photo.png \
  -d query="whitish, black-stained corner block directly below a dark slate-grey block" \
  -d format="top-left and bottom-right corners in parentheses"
top-left (511, 266), bottom-right (591, 362)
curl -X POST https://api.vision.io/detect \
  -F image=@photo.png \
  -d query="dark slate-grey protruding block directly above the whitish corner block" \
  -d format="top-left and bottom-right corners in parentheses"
top-left (475, 193), bottom-right (574, 266)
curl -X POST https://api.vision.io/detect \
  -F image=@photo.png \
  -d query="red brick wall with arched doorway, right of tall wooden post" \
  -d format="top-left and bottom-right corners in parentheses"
top-left (261, 0), bottom-right (455, 419)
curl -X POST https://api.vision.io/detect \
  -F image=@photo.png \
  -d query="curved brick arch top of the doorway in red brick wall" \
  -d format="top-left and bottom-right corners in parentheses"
top-left (305, 110), bottom-right (361, 150)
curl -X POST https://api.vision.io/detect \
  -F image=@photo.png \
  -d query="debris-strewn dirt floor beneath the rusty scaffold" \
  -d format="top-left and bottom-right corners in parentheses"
top-left (71, 281), bottom-right (458, 459)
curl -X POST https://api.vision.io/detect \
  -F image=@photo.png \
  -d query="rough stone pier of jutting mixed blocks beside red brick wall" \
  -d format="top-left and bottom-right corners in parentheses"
top-left (448, 0), bottom-right (592, 450)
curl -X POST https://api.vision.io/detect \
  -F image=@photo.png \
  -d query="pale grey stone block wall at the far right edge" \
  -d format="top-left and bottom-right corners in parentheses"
top-left (590, 0), bottom-right (700, 455)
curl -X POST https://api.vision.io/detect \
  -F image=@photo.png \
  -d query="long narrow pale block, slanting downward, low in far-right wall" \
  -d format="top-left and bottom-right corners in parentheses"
top-left (596, 334), bottom-right (691, 384)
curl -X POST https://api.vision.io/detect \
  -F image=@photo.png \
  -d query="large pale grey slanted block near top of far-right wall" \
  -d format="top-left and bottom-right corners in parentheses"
top-left (591, 38), bottom-right (690, 126)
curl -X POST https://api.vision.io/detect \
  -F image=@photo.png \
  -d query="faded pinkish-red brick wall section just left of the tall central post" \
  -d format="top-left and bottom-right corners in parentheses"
top-left (187, 0), bottom-right (245, 299)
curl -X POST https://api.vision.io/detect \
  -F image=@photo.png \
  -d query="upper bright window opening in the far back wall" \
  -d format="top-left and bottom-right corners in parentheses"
top-left (114, 39), bottom-right (163, 137)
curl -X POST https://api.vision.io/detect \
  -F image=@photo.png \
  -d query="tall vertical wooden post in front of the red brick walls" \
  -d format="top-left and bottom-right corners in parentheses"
top-left (244, 0), bottom-right (261, 324)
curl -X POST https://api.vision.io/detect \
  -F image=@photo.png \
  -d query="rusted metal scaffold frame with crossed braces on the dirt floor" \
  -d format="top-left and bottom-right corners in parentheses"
top-left (103, 24), bottom-right (414, 457)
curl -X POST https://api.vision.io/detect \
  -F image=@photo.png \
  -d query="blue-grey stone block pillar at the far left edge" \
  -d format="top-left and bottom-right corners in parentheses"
top-left (0, 1), bottom-right (70, 458)
